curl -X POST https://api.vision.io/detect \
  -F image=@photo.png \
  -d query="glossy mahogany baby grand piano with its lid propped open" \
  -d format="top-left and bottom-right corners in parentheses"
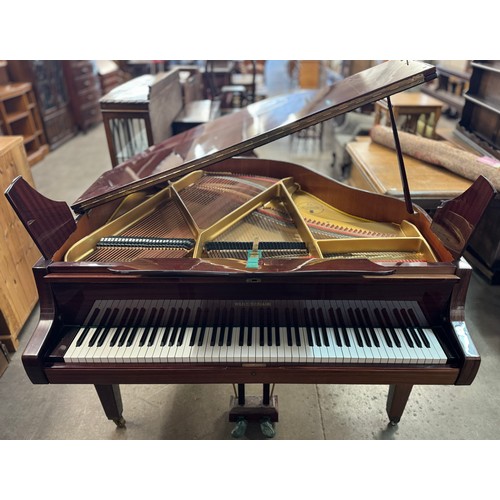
top-left (6, 61), bottom-right (494, 435)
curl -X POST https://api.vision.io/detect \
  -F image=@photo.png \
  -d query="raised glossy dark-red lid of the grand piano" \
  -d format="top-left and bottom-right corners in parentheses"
top-left (72, 61), bottom-right (436, 212)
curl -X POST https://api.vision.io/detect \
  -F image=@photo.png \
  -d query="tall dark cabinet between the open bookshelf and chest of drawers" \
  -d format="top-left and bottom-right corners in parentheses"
top-left (7, 61), bottom-right (76, 149)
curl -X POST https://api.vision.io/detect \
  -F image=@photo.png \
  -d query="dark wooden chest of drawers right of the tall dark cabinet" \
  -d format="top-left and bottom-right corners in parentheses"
top-left (62, 61), bottom-right (102, 131)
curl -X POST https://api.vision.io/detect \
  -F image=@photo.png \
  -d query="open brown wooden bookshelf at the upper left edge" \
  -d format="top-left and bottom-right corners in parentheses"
top-left (0, 83), bottom-right (49, 165)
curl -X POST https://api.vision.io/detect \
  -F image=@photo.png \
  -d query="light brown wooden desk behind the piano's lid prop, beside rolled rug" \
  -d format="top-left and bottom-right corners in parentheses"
top-left (346, 137), bottom-right (472, 211)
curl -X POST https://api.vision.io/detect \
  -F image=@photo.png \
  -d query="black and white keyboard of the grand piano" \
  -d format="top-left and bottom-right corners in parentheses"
top-left (60, 300), bottom-right (448, 364)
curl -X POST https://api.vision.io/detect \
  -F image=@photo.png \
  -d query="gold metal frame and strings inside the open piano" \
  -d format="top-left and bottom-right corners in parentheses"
top-left (66, 172), bottom-right (435, 263)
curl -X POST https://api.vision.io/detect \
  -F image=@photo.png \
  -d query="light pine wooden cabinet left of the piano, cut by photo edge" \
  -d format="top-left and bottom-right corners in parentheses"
top-left (0, 136), bottom-right (40, 351)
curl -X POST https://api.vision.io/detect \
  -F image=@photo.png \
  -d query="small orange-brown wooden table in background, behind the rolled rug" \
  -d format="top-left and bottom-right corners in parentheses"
top-left (374, 92), bottom-right (443, 139)
